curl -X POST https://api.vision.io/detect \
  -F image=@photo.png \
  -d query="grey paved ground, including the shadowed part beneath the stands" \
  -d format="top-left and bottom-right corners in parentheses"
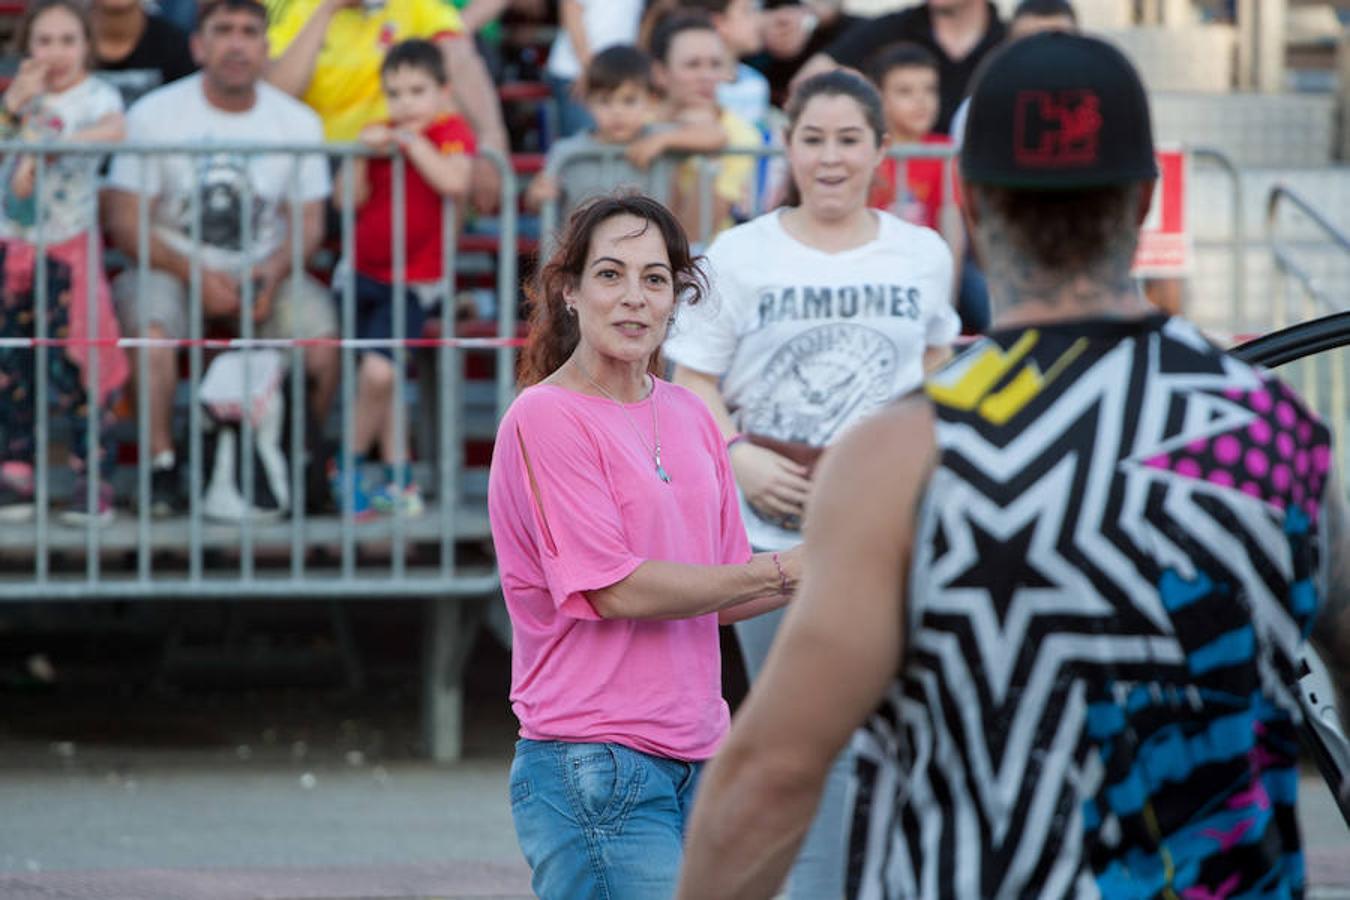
top-left (0, 609), bottom-right (1350, 900)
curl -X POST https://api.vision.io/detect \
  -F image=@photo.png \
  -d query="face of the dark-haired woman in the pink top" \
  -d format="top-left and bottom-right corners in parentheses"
top-left (563, 213), bottom-right (675, 364)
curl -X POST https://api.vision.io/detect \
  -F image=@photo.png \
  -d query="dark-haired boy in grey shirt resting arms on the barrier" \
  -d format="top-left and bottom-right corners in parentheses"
top-left (525, 45), bottom-right (725, 220)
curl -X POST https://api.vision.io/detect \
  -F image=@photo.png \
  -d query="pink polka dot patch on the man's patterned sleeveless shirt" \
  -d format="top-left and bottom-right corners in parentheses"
top-left (1145, 378), bottom-right (1332, 522)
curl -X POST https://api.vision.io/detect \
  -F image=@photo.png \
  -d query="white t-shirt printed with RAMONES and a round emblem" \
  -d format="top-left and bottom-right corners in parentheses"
top-left (664, 209), bottom-right (960, 549)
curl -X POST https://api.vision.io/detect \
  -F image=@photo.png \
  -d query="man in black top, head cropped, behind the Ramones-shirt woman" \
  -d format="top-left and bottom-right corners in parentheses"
top-left (794, 0), bottom-right (1007, 135)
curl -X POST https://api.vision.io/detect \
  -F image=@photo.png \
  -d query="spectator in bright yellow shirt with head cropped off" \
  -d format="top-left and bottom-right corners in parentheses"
top-left (267, 0), bottom-right (508, 212)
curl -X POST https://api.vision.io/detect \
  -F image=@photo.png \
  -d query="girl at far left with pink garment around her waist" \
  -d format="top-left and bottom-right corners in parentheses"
top-left (0, 0), bottom-right (130, 525)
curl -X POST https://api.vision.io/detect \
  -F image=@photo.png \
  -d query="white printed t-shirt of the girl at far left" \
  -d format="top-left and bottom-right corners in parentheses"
top-left (0, 76), bottom-right (122, 244)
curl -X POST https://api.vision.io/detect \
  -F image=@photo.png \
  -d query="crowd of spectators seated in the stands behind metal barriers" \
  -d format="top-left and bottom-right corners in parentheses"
top-left (0, 0), bottom-right (1085, 521)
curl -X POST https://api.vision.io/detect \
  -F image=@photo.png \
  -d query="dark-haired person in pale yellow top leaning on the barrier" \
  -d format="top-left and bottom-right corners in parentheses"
top-left (651, 11), bottom-right (760, 244)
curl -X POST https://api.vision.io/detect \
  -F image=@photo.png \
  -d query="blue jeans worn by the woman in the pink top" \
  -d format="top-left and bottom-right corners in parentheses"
top-left (510, 739), bottom-right (703, 900)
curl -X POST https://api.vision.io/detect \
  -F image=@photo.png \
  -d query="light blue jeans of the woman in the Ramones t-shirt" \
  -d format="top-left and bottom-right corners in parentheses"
top-left (732, 610), bottom-right (853, 900)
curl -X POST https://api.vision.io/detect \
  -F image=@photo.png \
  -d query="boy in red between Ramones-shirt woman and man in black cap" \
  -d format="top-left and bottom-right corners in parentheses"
top-left (868, 43), bottom-right (950, 231)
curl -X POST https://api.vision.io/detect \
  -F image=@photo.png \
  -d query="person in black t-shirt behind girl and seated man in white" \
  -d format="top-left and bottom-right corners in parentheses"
top-left (90, 0), bottom-right (197, 107)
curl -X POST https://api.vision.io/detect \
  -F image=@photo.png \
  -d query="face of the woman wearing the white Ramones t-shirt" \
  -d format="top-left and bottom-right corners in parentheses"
top-left (787, 94), bottom-right (884, 219)
